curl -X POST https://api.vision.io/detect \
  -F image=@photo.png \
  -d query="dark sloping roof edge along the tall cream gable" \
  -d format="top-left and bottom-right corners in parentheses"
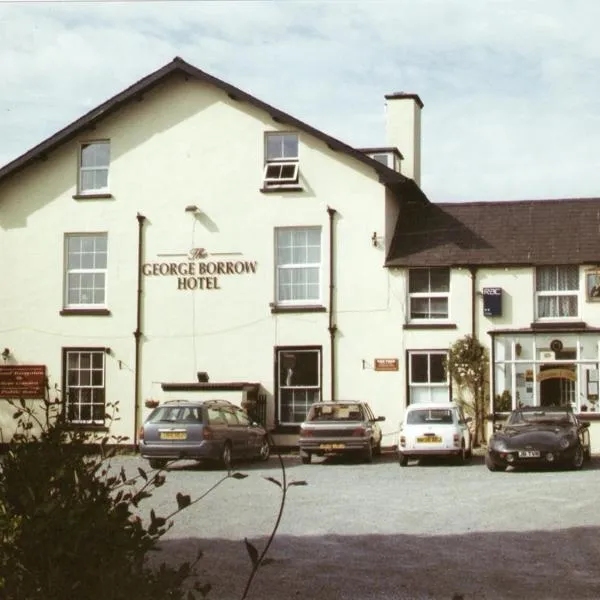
top-left (0, 56), bottom-right (426, 201)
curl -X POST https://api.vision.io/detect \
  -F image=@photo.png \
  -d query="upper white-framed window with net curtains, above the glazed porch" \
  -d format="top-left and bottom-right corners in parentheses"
top-left (535, 265), bottom-right (579, 319)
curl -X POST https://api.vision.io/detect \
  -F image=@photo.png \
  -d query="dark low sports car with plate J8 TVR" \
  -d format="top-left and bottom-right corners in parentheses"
top-left (485, 406), bottom-right (591, 471)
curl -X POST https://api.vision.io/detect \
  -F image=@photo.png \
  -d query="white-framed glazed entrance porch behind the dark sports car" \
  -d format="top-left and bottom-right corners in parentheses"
top-left (491, 332), bottom-right (600, 413)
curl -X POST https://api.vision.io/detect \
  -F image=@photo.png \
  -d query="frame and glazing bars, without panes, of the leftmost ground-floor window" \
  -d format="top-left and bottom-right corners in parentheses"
top-left (62, 346), bottom-right (106, 427)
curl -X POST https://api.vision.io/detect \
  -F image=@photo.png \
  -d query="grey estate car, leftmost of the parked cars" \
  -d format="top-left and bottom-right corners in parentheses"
top-left (138, 400), bottom-right (270, 469)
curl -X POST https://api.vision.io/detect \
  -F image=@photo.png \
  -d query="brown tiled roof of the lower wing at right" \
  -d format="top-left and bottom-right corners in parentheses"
top-left (386, 198), bottom-right (600, 267)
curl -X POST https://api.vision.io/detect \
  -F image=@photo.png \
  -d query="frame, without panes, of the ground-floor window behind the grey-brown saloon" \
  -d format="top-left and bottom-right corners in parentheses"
top-left (275, 346), bottom-right (323, 426)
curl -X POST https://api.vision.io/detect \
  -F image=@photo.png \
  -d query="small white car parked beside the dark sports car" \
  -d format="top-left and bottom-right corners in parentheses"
top-left (398, 402), bottom-right (472, 467)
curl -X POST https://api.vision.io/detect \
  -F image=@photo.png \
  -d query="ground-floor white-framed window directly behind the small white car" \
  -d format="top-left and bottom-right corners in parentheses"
top-left (408, 351), bottom-right (450, 404)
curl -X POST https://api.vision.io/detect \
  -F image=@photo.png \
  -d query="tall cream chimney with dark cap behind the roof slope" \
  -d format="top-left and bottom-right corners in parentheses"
top-left (385, 92), bottom-right (423, 187)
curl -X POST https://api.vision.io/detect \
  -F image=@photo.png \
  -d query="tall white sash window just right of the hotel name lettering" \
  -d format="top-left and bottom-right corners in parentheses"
top-left (275, 227), bottom-right (321, 305)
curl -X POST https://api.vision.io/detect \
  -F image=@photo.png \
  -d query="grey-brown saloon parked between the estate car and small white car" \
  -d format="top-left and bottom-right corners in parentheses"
top-left (298, 401), bottom-right (385, 464)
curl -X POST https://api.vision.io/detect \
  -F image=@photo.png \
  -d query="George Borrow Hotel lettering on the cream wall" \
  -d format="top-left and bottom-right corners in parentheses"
top-left (142, 248), bottom-right (256, 290)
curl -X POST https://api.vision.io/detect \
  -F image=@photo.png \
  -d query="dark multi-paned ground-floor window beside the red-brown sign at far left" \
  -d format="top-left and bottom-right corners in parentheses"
top-left (63, 348), bottom-right (106, 425)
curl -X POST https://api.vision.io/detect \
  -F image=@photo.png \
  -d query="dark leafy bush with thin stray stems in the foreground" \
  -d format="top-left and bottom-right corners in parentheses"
top-left (0, 400), bottom-right (306, 600)
